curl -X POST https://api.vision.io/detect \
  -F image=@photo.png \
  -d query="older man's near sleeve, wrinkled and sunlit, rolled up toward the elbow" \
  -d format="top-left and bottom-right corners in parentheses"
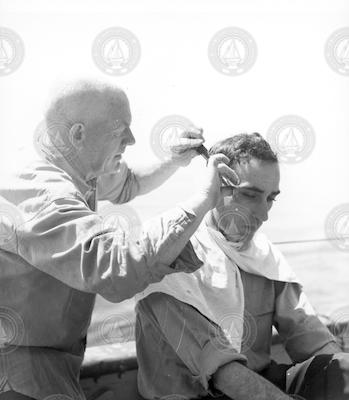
top-left (17, 197), bottom-right (202, 302)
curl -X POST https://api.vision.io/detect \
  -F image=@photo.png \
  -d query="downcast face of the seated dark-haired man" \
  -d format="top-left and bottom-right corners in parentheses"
top-left (212, 158), bottom-right (280, 249)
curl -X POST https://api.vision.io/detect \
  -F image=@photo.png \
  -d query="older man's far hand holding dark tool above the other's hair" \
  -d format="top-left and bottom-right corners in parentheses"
top-left (169, 127), bottom-right (205, 167)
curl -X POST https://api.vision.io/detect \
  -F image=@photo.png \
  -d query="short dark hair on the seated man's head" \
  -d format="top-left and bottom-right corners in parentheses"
top-left (209, 132), bottom-right (278, 165)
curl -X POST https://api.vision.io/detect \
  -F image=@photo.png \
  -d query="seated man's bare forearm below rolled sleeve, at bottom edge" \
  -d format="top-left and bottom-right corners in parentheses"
top-left (213, 362), bottom-right (290, 400)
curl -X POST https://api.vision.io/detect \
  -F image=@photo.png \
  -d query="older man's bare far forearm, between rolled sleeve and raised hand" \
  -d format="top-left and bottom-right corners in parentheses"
top-left (132, 160), bottom-right (179, 195)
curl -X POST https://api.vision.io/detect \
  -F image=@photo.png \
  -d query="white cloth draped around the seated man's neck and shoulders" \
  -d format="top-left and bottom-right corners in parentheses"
top-left (136, 220), bottom-right (300, 352)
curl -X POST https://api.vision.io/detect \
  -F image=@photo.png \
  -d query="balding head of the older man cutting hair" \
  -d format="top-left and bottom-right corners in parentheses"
top-left (40, 80), bottom-right (135, 176)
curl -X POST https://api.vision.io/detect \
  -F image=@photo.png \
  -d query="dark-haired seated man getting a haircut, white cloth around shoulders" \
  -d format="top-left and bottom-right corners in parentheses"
top-left (136, 133), bottom-right (348, 400)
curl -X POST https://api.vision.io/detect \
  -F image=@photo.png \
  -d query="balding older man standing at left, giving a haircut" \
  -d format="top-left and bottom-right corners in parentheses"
top-left (0, 82), bottom-right (237, 400)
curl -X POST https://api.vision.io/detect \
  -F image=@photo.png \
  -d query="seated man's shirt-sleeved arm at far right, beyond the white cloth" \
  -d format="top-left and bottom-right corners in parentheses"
top-left (274, 282), bottom-right (340, 362)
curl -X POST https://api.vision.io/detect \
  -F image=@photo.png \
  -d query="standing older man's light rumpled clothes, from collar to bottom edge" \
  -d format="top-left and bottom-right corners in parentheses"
top-left (0, 155), bottom-right (201, 399)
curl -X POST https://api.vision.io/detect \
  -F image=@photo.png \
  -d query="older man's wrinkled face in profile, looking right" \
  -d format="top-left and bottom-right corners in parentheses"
top-left (83, 96), bottom-right (135, 173)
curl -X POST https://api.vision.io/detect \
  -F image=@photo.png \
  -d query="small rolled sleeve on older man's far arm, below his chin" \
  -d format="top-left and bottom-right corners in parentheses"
top-left (97, 161), bottom-right (139, 204)
